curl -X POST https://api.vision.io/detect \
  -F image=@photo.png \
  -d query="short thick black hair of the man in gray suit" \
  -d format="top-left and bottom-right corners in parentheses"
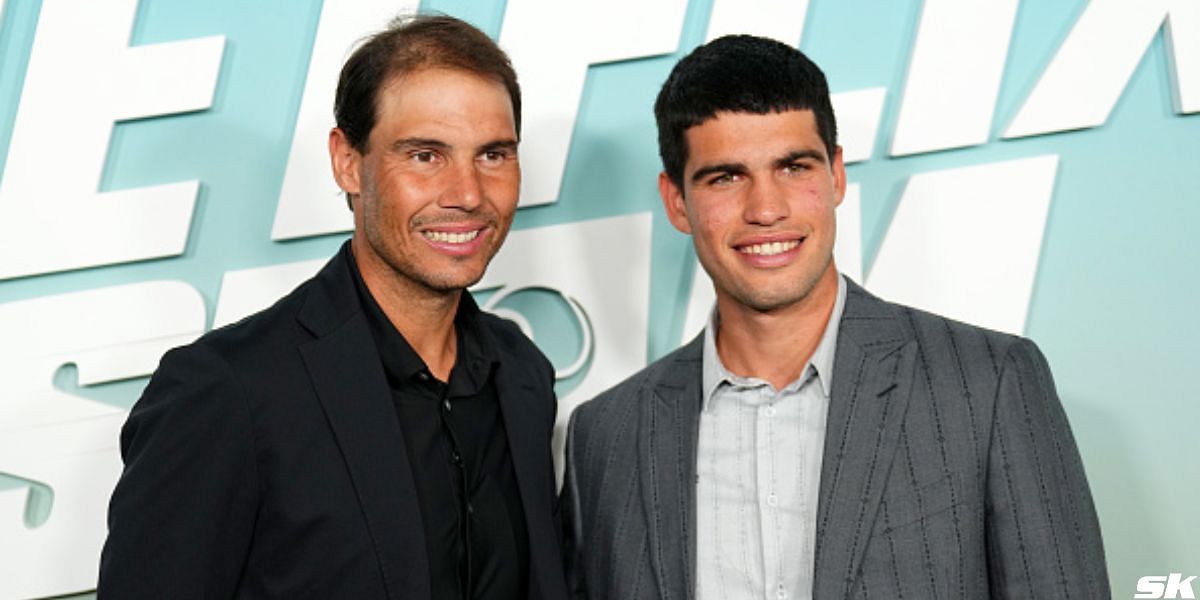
top-left (654, 35), bottom-right (838, 190)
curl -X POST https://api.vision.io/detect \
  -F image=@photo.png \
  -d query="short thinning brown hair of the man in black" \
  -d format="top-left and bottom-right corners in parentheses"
top-left (334, 14), bottom-right (521, 152)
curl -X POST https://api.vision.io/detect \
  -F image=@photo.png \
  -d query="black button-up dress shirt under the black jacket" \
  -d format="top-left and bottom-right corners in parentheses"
top-left (354, 266), bottom-right (529, 600)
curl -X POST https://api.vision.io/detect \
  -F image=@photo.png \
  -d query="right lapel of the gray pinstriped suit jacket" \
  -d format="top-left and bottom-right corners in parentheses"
top-left (814, 281), bottom-right (917, 599)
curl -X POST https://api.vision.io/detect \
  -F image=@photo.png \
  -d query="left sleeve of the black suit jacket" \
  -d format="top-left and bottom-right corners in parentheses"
top-left (97, 344), bottom-right (258, 600)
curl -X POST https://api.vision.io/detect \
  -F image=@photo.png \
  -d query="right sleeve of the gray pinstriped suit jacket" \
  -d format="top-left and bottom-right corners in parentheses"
top-left (986, 340), bottom-right (1110, 599)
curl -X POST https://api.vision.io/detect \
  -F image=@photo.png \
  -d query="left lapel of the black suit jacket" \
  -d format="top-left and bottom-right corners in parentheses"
top-left (299, 247), bottom-right (430, 599)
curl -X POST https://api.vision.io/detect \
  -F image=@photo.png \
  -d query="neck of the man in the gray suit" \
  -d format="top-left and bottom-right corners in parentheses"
top-left (716, 265), bottom-right (838, 389)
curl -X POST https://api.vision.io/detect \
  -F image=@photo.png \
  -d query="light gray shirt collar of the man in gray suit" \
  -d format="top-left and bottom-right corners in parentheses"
top-left (702, 274), bottom-right (846, 409)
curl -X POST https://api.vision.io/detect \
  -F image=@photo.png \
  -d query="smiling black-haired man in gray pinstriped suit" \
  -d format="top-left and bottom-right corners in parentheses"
top-left (562, 36), bottom-right (1110, 600)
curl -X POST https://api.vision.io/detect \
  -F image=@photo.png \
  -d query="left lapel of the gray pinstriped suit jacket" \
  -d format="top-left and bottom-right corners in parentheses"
top-left (637, 334), bottom-right (703, 600)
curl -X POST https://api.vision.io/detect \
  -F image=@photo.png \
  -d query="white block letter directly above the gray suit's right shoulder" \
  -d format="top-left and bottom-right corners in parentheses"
top-left (866, 155), bottom-right (1058, 334)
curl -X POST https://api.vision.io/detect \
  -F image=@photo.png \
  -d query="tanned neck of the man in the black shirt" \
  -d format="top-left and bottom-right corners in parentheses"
top-left (354, 241), bottom-right (463, 382)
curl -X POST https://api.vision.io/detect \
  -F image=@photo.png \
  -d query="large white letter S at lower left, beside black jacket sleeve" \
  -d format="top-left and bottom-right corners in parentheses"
top-left (0, 281), bottom-right (205, 598)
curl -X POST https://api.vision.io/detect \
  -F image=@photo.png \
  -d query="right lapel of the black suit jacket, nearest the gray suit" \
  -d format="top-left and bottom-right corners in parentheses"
top-left (496, 360), bottom-right (563, 598)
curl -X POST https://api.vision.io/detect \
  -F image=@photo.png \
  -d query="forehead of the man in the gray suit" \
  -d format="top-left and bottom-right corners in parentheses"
top-left (684, 109), bottom-right (826, 169)
